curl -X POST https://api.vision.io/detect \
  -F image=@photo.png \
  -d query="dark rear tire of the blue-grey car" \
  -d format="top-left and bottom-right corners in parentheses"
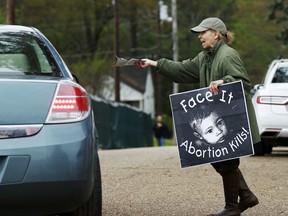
top-left (59, 156), bottom-right (102, 216)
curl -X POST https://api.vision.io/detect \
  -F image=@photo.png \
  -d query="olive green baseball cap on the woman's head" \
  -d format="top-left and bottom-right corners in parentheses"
top-left (191, 17), bottom-right (227, 35)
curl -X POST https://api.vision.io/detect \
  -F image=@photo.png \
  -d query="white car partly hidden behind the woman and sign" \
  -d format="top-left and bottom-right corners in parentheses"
top-left (252, 59), bottom-right (288, 155)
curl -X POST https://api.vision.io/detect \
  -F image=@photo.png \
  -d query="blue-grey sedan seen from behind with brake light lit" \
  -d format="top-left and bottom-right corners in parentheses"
top-left (0, 25), bottom-right (102, 216)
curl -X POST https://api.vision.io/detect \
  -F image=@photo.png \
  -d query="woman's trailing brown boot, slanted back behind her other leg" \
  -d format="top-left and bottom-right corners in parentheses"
top-left (237, 169), bottom-right (259, 213)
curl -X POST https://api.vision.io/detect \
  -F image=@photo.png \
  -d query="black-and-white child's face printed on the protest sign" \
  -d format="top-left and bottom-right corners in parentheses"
top-left (198, 113), bottom-right (228, 144)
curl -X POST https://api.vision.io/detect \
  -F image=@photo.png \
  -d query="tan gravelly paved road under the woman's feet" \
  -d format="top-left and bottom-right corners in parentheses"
top-left (99, 146), bottom-right (288, 216)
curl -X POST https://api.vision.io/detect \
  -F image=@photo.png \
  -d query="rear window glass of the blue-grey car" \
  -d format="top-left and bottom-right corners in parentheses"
top-left (0, 33), bottom-right (61, 76)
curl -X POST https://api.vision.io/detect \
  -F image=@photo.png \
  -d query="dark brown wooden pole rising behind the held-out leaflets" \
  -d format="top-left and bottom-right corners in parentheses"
top-left (113, 0), bottom-right (120, 102)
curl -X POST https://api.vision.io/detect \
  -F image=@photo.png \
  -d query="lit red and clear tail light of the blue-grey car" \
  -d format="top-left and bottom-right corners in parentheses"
top-left (46, 81), bottom-right (91, 123)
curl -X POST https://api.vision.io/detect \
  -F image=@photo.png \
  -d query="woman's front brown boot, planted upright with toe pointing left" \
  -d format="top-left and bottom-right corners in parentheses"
top-left (211, 172), bottom-right (240, 216)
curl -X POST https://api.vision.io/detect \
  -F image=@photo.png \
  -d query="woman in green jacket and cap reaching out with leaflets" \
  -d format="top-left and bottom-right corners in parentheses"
top-left (137, 17), bottom-right (260, 216)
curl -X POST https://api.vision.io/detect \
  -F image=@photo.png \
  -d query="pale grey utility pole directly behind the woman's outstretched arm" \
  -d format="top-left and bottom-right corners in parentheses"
top-left (171, 0), bottom-right (179, 93)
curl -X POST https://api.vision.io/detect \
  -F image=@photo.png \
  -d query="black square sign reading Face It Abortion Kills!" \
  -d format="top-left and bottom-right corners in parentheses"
top-left (170, 81), bottom-right (254, 168)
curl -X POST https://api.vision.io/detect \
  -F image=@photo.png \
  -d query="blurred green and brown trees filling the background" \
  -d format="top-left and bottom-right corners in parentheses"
top-left (0, 0), bottom-right (288, 113)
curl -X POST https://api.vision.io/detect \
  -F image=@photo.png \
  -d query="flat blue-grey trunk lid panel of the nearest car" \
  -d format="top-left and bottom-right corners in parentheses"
top-left (0, 79), bottom-right (57, 126)
